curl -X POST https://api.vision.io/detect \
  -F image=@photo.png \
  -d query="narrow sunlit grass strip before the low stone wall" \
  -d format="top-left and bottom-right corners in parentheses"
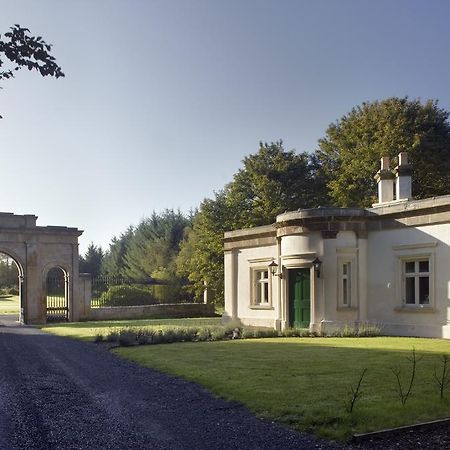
top-left (39, 317), bottom-right (221, 341)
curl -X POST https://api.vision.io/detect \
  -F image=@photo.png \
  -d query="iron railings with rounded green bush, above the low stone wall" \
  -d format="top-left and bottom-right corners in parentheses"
top-left (91, 276), bottom-right (192, 308)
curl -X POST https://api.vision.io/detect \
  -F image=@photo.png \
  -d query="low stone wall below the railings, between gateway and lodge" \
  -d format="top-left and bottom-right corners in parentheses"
top-left (85, 303), bottom-right (214, 320)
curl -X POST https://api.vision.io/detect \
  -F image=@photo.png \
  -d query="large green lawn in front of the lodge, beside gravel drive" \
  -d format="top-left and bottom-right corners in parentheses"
top-left (114, 337), bottom-right (450, 440)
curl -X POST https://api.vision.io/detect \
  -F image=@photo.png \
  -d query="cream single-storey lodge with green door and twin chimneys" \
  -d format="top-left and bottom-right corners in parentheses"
top-left (224, 153), bottom-right (450, 338)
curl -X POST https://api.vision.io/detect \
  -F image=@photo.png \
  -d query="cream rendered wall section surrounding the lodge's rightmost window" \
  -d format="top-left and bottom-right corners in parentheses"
top-left (367, 224), bottom-right (450, 338)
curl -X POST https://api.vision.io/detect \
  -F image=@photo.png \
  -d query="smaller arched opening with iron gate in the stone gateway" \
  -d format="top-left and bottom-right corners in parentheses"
top-left (45, 267), bottom-right (69, 322)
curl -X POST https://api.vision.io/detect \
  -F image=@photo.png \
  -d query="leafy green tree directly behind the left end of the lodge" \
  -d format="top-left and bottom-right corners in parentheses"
top-left (177, 141), bottom-right (328, 303)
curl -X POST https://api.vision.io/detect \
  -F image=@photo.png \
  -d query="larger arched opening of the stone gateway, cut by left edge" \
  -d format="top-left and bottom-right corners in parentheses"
top-left (0, 251), bottom-right (24, 323)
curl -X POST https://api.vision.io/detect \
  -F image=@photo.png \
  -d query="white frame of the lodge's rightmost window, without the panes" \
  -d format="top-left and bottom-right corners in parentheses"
top-left (399, 253), bottom-right (434, 309)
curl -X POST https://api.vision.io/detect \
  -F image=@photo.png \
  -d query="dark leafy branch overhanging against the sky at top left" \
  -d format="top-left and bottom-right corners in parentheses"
top-left (0, 25), bottom-right (64, 118)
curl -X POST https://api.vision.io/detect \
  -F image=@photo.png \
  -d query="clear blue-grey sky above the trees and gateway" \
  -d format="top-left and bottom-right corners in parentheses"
top-left (0, 0), bottom-right (450, 253)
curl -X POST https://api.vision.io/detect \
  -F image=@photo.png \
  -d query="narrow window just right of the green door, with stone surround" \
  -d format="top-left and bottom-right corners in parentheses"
top-left (337, 253), bottom-right (358, 310)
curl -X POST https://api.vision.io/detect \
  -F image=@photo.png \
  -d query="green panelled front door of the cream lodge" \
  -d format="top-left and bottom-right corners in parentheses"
top-left (289, 268), bottom-right (311, 328)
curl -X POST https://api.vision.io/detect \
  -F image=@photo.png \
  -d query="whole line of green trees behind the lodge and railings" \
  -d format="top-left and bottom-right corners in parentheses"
top-left (81, 97), bottom-right (450, 304)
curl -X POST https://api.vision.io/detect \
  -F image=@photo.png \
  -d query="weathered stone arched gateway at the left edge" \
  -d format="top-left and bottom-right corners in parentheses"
top-left (0, 213), bottom-right (84, 324)
